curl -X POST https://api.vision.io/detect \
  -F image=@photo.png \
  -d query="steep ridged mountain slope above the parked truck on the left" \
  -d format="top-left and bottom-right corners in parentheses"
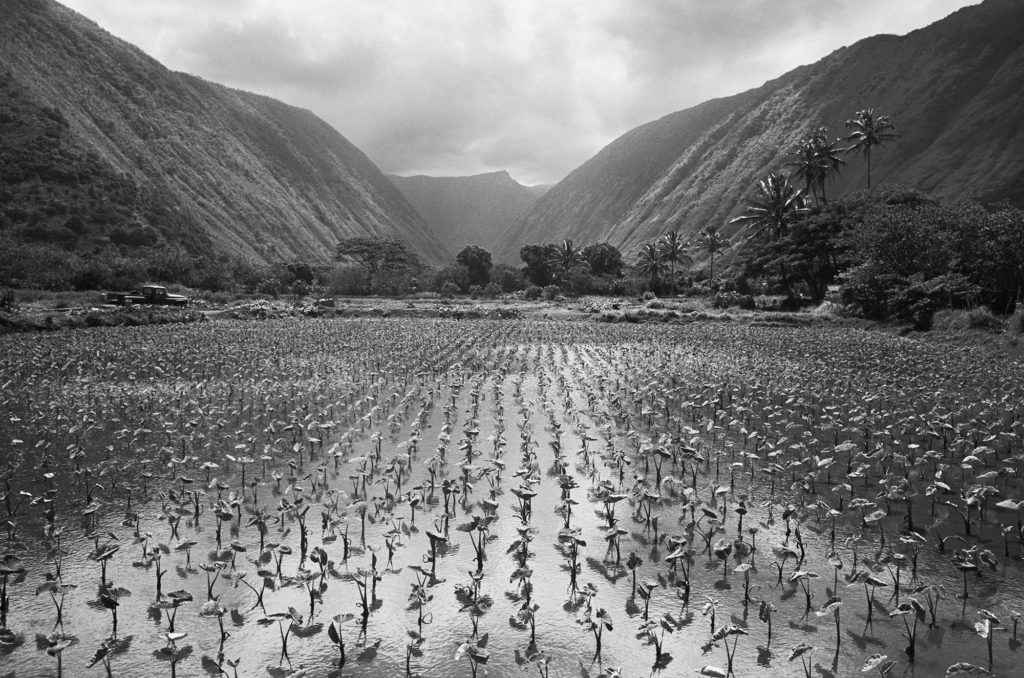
top-left (0, 0), bottom-right (451, 264)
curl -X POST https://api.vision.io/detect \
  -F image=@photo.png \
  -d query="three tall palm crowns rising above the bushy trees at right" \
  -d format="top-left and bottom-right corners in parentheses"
top-left (730, 109), bottom-right (899, 240)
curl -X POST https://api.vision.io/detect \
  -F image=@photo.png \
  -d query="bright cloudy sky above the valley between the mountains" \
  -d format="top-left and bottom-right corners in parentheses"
top-left (61, 0), bottom-right (977, 184)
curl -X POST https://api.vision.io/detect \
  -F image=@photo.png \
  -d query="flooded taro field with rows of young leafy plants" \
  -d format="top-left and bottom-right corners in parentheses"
top-left (0, 320), bottom-right (1024, 678)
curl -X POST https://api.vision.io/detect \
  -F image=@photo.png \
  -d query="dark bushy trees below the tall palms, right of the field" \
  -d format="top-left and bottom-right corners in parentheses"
top-left (733, 188), bottom-right (1024, 328)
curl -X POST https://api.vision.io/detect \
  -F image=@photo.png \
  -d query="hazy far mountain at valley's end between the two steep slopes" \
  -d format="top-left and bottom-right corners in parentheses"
top-left (389, 172), bottom-right (549, 262)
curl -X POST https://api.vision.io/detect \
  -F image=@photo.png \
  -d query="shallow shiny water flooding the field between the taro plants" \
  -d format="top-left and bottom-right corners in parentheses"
top-left (0, 321), bottom-right (1024, 676)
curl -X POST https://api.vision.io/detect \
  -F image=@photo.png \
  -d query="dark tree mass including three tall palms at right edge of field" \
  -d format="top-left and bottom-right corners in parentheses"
top-left (730, 110), bottom-right (1024, 327)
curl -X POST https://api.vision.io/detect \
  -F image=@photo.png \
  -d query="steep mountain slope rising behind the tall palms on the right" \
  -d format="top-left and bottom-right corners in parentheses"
top-left (498, 0), bottom-right (1024, 260)
